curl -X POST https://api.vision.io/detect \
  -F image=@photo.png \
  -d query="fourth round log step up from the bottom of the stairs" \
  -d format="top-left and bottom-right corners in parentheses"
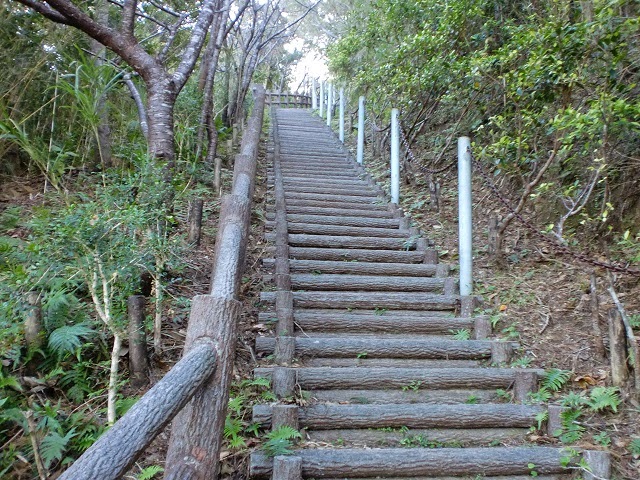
top-left (256, 337), bottom-right (492, 360)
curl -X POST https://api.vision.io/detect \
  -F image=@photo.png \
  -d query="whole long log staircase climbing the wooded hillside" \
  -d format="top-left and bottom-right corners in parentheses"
top-left (250, 109), bottom-right (609, 480)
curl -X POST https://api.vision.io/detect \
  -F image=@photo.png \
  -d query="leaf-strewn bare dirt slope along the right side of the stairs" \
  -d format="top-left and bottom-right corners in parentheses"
top-left (347, 134), bottom-right (640, 479)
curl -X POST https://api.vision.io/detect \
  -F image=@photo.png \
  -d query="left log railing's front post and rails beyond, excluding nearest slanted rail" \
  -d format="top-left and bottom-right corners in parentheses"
top-left (165, 86), bottom-right (265, 480)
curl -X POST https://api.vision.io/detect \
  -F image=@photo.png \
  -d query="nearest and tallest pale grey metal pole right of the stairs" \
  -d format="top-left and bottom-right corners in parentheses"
top-left (458, 137), bottom-right (473, 296)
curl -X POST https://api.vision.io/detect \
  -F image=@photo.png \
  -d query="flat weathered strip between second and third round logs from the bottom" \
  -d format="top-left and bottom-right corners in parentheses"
top-left (310, 384), bottom-right (500, 405)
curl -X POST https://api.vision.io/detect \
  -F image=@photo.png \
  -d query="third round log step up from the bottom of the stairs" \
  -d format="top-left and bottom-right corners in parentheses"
top-left (254, 367), bottom-right (544, 390)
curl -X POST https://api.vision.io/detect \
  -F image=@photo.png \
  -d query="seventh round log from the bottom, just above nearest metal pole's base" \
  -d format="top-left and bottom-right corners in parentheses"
top-left (291, 273), bottom-right (445, 293)
